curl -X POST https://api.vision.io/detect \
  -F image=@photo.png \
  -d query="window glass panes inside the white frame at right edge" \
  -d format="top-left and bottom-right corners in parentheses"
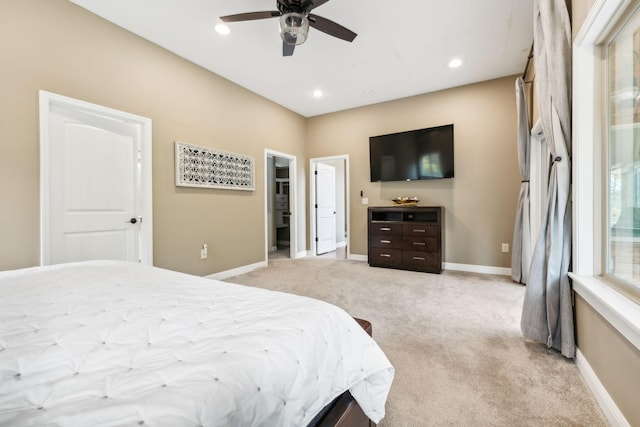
top-left (603, 3), bottom-right (640, 295)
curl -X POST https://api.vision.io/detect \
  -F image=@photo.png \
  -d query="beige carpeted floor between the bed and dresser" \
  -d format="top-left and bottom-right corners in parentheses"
top-left (228, 258), bottom-right (607, 427)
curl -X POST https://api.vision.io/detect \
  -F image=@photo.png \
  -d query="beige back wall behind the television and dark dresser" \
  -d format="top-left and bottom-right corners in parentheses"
top-left (307, 76), bottom-right (521, 267)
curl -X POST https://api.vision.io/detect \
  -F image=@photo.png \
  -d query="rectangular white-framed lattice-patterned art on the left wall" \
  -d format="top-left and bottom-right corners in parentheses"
top-left (176, 141), bottom-right (255, 191)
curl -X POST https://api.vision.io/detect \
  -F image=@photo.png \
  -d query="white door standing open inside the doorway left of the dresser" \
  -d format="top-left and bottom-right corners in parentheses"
top-left (315, 163), bottom-right (336, 254)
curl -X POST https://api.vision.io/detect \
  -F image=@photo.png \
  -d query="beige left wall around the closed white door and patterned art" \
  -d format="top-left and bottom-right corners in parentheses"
top-left (0, 0), bottom-right (306, 275)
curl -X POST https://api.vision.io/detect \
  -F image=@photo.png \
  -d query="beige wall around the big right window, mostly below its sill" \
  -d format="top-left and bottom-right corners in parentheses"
top-left (572, 0), bottom-right (640, 426)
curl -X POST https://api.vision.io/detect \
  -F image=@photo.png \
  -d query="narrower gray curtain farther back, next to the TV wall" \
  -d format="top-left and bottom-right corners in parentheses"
top-left (511, 77), bottom-right (531, 284)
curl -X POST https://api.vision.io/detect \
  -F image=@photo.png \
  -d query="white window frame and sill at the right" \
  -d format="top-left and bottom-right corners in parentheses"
top-left (569, 0), bottom-right (640, 349)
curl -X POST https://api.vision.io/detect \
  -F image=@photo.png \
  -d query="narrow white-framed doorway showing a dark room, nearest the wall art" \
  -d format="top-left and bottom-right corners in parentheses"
top-left (265, 150), bottom-right (296, 261)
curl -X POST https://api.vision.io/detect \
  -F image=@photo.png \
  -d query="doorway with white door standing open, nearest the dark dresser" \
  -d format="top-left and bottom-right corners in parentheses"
top-left (309, 155), bottom-right (350, 259)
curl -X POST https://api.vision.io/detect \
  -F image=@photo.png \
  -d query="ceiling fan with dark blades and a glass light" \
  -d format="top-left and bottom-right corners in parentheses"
top-left (220, 0), bottom-right (357, 56)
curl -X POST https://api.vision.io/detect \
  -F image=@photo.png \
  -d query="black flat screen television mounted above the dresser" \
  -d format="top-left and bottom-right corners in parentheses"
top-left (369, 124), bottom-right (454, 182)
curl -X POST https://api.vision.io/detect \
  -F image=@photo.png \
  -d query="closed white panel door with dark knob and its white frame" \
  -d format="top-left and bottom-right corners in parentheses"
top-left (42, 92), bottom-right (151, 264)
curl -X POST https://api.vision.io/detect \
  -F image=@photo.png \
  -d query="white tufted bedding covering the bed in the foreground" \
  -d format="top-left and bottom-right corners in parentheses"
top-left (0, 261), bottom-right (394, 426)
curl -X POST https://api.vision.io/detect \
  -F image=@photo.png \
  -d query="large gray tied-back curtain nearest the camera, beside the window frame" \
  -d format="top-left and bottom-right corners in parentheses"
top-left (520, 0), bottom-right (575, 358)
